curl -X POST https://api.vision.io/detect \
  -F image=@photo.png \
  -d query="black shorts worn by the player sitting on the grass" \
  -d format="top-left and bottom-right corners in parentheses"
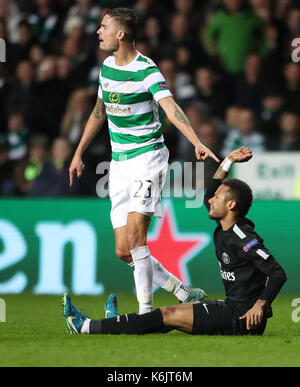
top-left (192, 300), bottom-right (267, 336)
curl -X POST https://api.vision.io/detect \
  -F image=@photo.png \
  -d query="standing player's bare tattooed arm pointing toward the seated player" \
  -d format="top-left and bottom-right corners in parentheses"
top-left (159, 97), bottom-right (220, 162)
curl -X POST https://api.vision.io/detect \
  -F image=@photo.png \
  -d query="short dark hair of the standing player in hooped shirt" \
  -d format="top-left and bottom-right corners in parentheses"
top-left (105, 7), bottom-right (140, 41)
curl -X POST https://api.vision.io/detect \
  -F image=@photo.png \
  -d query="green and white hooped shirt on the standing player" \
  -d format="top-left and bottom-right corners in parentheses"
top-left (98, 53), bottom-right (172, 161)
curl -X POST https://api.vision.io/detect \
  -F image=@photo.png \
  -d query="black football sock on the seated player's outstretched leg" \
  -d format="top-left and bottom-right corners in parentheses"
top-left (90, 309), bottom-right (166, 335)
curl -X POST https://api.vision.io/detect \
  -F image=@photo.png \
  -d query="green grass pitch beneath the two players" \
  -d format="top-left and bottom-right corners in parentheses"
top-left (0, 293), bottom-right (300, 367)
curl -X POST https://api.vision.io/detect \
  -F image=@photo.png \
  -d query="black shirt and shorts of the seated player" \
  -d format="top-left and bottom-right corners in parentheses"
top-left (193, 179), bottom-right (286, 335)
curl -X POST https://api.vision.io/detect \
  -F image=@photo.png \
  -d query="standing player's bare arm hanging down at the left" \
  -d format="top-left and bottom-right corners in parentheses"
top-left (69, 97), bottom-right (106, 187)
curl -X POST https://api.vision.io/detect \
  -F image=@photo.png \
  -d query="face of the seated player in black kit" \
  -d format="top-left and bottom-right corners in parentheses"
top-left (208, 184), bottom-right (232, 220)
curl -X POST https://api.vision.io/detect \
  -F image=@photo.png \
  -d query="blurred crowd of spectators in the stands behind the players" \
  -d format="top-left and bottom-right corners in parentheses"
top-left (0, 0), bottom-right (300, 197)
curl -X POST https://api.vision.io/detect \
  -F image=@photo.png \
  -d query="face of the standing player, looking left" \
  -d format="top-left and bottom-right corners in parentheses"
top-left (97, 15), bottom-right (122, 52)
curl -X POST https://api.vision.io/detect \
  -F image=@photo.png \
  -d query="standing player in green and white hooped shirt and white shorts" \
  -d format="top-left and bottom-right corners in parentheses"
top-left (70, 8), bottom-right (219, 314)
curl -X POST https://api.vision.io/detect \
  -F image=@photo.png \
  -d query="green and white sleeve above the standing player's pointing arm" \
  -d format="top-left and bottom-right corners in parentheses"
top-left (144, 66), bottom-right (173, 102)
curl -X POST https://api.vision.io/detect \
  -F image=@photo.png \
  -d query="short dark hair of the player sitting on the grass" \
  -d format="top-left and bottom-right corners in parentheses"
top-left (223, 179), bottom-right (253, 217)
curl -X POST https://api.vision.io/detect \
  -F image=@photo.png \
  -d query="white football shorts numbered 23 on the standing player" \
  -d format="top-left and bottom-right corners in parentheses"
top-left (109, 147), bottom-right (169, 229)
